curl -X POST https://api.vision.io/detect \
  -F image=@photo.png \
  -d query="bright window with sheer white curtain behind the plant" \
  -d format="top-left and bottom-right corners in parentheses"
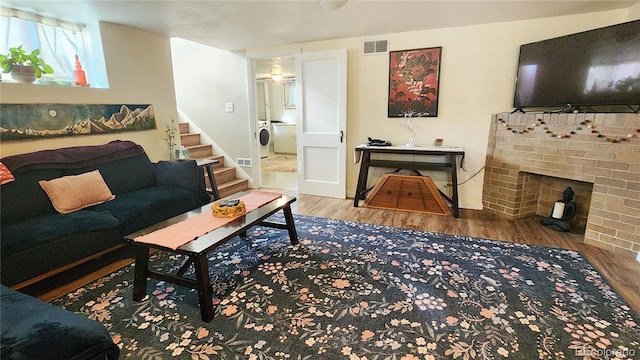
top-left (0, 7), bottom-right (108, 88)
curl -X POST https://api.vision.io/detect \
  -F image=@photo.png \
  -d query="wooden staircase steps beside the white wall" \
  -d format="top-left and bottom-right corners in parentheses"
top-left (179, 123), bottom-right (249, 198)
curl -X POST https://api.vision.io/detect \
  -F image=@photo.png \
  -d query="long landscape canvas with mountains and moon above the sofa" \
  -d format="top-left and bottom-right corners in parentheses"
top-left (0, 104), bottom-right (156, 141)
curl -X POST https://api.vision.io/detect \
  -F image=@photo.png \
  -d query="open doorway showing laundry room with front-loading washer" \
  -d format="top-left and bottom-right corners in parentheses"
top-left (254, 56), bottom-right (298, 191)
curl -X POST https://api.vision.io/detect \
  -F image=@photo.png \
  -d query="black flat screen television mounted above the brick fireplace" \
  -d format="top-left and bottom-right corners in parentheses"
top-left (513, 20), bottom-right (640, 109)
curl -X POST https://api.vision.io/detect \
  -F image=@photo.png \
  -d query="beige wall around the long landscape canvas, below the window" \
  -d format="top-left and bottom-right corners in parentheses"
top-left (0, 23), bottom-right (177, 161)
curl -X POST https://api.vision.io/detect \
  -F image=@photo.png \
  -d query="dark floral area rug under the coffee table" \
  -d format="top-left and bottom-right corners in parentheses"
top-left (53, 214), bottom-right (640, 360)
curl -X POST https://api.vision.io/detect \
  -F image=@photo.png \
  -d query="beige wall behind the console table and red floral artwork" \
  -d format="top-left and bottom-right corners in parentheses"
top-left (250, 9), bottom-right (634, 209)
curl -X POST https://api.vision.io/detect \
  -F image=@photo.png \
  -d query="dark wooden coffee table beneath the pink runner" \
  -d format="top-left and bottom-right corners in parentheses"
top-left (124, 196), bottom-right (298, 322)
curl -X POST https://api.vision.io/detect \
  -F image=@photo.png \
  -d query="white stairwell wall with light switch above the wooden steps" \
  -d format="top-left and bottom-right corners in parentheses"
top-left (171, 39), bottom-right (252, 177)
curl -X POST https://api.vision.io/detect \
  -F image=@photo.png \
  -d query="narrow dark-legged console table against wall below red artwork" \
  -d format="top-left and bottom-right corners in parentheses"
top-left (353, 145), bottom-right (464, 218)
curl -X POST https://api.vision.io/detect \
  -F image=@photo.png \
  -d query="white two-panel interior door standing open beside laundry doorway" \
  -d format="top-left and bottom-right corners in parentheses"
top-left (296, 49), bottom-right (347, 199)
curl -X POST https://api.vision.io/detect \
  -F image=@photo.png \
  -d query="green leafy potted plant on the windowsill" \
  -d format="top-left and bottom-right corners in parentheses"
top-left (0, 45), bottom-right (53, 83)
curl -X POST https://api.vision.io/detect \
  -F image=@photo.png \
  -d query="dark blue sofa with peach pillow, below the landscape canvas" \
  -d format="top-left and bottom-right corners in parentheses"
top-left (0, 141), bottom-right (211, 286)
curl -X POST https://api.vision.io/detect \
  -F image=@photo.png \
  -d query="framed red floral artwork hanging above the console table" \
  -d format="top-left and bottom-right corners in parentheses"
top-left (388, 46), bottom-right (442, 118)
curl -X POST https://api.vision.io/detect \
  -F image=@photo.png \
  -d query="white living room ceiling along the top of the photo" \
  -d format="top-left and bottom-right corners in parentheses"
top-left (2, 0), bottom-right (638, 77)
